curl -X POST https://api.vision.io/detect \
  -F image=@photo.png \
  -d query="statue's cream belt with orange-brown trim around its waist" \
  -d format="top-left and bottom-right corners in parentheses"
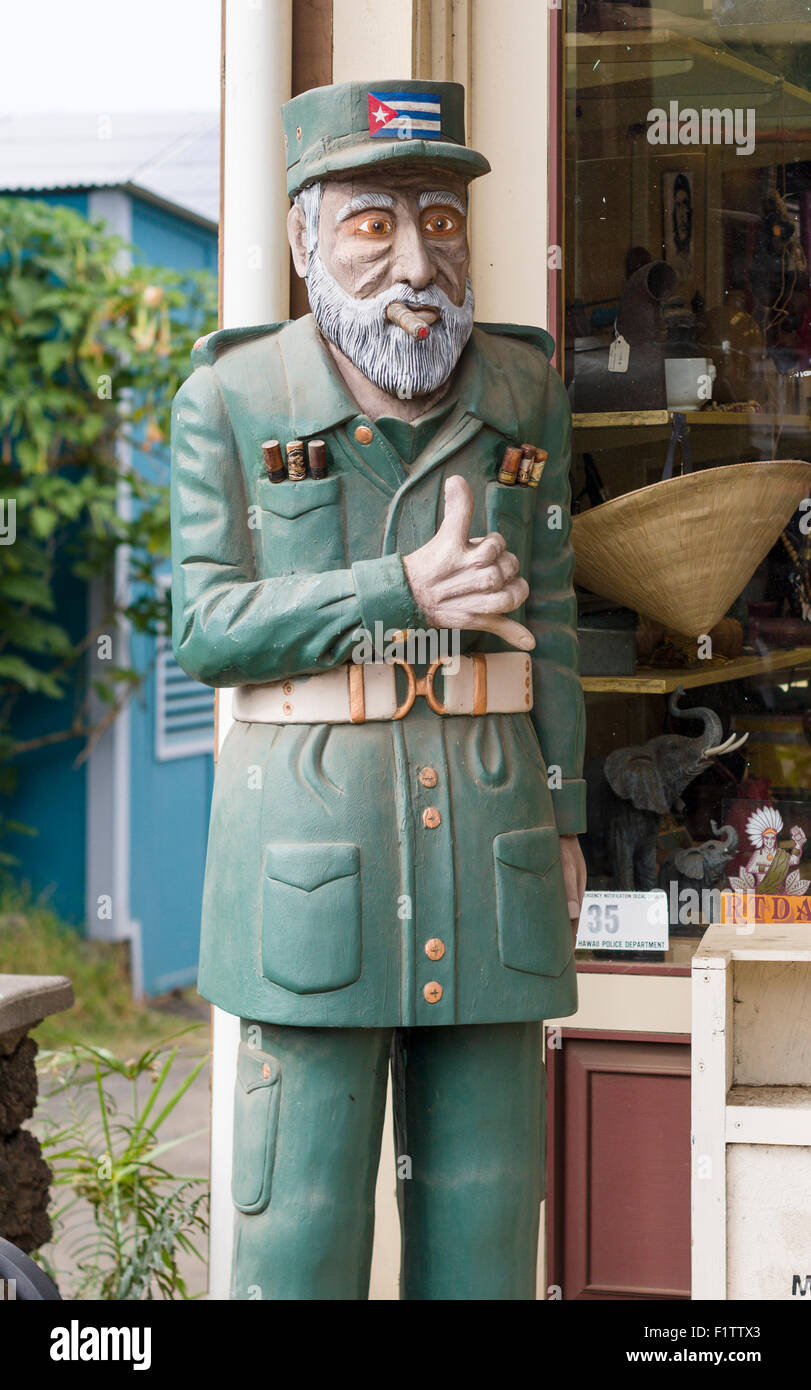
top-left (232, 652), bottom-right (533, 724)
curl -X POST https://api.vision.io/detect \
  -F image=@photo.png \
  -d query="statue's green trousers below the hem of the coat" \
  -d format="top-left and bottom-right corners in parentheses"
top-left (231, 1020), bottom-right (545, 1300)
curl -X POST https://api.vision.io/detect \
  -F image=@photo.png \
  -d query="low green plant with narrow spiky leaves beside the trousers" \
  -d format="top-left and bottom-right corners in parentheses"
top-left (40, 1024), bottom-right (207, 1301)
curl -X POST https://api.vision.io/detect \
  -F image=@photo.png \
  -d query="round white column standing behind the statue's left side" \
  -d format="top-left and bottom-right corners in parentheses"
top-left (209, 0), bottom-right (292, 1298)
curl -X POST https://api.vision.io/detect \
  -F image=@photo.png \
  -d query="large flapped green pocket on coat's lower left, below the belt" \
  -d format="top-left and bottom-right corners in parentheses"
top-left (262, 845), bottom-right (362, 994)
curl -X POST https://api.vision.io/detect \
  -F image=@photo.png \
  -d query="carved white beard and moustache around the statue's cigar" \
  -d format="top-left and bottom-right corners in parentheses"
top-left (305, 247), bottom-right (473, 400)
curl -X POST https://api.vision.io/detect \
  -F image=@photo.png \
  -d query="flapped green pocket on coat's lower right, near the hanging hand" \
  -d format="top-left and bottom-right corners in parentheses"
top-left (492, 826), bottom-right (575, 977)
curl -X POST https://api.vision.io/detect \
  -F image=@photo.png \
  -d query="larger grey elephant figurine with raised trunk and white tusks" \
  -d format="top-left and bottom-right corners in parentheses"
top-left (602, 685), bottom-right (748, 891)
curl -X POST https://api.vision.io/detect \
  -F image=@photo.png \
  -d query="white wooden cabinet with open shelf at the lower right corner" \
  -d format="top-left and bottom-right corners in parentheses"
top-left (691, 923), bottom-right (811, 1301)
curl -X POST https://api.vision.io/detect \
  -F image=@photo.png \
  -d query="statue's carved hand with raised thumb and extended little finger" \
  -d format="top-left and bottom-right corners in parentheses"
top-left (403, 475), bottom-right (536, 652)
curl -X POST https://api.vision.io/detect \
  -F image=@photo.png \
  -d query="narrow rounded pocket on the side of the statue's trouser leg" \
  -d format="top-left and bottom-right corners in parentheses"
top-left (231, 1043), bottom-right (281, 1213)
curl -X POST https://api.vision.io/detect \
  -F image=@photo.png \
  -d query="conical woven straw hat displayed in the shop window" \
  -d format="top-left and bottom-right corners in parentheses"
top-left (572, 459), bottom-right (811, 637)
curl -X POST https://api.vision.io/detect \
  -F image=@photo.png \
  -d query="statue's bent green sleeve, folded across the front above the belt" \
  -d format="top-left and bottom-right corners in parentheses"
top-left (171, 366), bottom-right (424, 685)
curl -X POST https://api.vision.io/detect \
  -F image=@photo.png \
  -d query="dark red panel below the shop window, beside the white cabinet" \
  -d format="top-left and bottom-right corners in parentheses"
top-left (547, 1030), bottom-right (690, 1300)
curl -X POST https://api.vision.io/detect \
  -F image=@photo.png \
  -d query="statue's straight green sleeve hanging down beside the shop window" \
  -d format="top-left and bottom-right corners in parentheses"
top-left (526, 368), bottom-right (586, 835)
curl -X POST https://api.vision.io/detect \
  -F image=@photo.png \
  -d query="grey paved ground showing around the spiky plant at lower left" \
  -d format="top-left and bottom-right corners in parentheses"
top-left (31, 999), bottom-right (210, 1298)
